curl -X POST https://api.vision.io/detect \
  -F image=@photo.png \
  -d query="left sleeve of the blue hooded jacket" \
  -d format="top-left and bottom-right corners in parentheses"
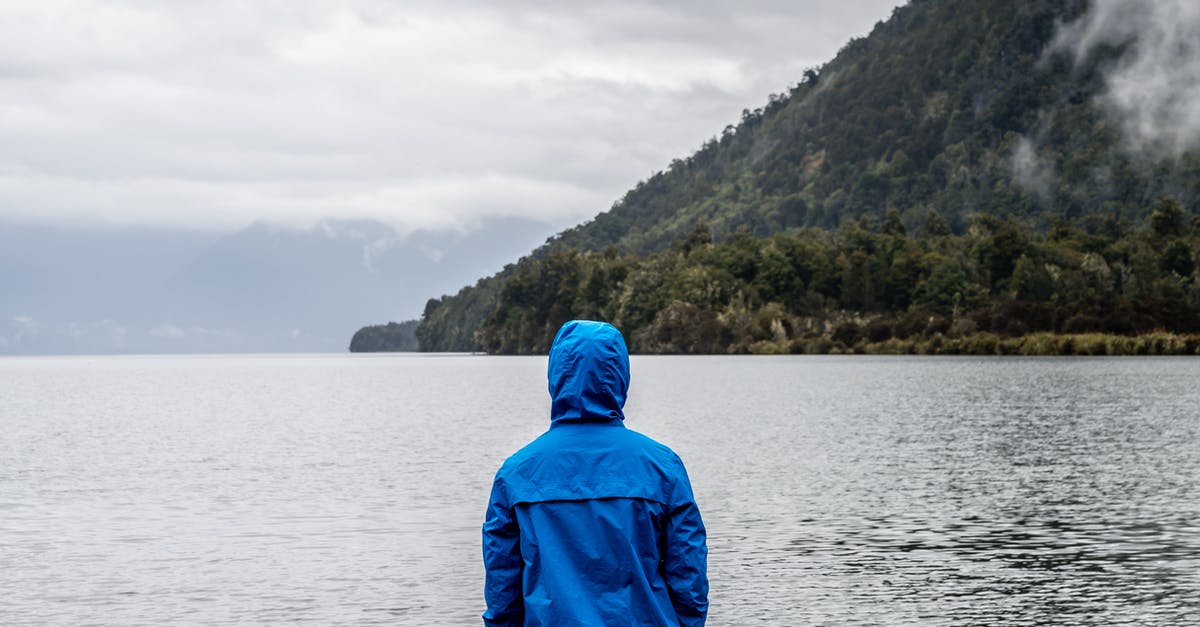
top-left (484, 474), bottom-right (524, 627)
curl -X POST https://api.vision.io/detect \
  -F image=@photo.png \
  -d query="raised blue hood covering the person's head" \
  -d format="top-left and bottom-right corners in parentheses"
top-left (546, 320), bottom-right (629, 424)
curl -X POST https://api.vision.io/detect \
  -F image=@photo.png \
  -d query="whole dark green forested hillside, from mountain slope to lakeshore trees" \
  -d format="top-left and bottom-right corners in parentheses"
top-left (418, 0), bottom-right (1200, 352)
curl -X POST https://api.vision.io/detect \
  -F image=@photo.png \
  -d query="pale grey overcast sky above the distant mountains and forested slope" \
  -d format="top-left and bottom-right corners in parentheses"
top-left (0, 0), bottom-right (901, 231)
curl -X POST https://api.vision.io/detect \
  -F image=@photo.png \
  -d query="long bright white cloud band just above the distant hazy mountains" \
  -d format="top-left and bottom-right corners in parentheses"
top-left (0, 172), bottom-right (612, 234)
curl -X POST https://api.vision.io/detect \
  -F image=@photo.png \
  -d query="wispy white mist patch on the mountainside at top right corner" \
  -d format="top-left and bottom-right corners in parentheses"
top-left (1051, 0), bottom-right (1200, 157)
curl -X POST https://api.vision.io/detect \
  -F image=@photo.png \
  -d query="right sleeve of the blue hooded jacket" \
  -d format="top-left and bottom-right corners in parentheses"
top-left (662, 464), bottom-right (708, 627)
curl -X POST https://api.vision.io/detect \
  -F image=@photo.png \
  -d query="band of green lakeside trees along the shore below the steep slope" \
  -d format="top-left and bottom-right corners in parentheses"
top-left (439, 198), bottom-right (1200, 354)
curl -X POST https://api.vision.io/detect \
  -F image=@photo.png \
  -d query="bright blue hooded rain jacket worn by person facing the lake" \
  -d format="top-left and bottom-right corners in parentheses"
top-left (484, 321), bottom-right (708, 627)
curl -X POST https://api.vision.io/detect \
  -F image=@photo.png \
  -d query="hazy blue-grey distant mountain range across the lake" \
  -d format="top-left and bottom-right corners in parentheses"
top-left (0, 219), bottom-right (550, 354)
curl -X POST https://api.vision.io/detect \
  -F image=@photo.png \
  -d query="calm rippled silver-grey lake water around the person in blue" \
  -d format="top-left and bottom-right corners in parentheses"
top-left (0, 356), bottom-right (1200, 626)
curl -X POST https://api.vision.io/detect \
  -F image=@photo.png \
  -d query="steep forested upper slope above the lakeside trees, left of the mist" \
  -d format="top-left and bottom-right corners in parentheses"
top-left (556, 0), bottom-right (1099, 253)
